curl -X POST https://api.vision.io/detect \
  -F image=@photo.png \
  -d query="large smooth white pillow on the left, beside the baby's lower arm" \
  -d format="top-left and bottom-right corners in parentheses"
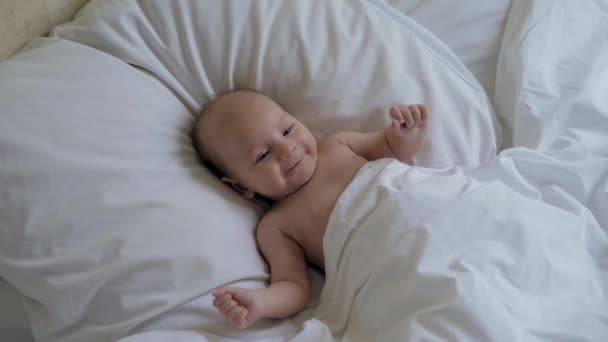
top-left (0, 38), bottom-right (297, 342)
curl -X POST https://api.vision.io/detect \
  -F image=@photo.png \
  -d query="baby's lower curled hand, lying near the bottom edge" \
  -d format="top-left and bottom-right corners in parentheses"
top-left (213, 287), bottom-right (264, 329)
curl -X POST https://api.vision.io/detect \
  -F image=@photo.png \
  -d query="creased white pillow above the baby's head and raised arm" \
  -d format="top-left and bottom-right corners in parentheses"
top-left (52, 0), bottom-right (500, 166)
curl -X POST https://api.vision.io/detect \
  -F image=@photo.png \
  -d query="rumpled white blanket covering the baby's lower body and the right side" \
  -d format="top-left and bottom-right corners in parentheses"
top-left (299, 0), bottom-right (608, 341)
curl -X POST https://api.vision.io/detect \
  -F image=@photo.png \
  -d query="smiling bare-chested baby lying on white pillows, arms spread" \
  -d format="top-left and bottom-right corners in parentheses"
top-left (193, 90), bottom-right (428, 328)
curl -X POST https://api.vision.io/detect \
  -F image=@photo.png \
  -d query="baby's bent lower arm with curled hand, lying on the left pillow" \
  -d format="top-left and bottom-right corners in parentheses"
top-left (213, 219), bottom-right (310, 328)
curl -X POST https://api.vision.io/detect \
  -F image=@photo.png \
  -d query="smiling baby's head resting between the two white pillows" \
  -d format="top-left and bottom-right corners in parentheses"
top-left (193, 90), bottom-right (317, 200)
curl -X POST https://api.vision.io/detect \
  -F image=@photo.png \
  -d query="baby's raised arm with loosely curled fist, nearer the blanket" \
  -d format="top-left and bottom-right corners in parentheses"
top-left (328, 104), bottom-right (428, 162)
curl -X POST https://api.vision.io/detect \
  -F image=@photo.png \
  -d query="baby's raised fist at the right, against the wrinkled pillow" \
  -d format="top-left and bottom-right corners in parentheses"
top-left (386, 104), bottom-right (429, 162)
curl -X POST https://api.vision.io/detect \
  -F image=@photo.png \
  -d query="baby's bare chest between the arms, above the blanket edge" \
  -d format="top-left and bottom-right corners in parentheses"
top-left (276, 139), bottom-right (367, 269)
